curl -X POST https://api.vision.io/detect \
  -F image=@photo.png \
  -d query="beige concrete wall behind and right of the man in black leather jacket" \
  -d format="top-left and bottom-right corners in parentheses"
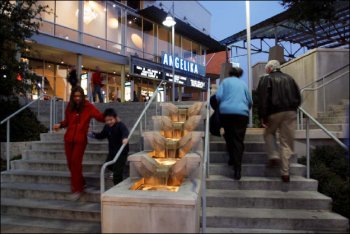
top-left (282, 48), bottom-right (349, 116)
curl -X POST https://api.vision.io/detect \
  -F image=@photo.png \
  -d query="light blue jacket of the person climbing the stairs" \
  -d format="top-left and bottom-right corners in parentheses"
top-left (216, 77), bottom-right (253, 116)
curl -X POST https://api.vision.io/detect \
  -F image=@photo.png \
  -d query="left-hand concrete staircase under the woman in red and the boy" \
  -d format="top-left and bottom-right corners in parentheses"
top-left (1, 132), bottom-right (139, 233)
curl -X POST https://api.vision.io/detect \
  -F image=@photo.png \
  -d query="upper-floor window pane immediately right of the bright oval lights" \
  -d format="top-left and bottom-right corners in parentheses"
top-left (143, 19), bottom-right (155, 61)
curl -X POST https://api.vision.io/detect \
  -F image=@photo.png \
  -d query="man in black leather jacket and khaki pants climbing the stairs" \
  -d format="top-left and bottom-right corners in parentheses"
top-left (257, 60), bottom-right (301, 182)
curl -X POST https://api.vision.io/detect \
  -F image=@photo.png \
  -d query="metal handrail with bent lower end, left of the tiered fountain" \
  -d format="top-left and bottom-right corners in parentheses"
top-left (100, 80), bottom-right (165, 195)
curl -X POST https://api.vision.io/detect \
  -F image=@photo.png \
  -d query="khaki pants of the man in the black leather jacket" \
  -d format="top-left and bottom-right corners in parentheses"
top-left (264, 111), bottom-right (297, 175)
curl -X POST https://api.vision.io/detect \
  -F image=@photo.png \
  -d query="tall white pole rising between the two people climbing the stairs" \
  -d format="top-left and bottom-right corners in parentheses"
top-left (245, 1), bottom-right (253, 127)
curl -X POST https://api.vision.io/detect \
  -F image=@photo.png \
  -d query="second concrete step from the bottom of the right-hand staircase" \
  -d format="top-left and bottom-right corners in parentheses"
top-left (207, 189), bottom-right (332, 210)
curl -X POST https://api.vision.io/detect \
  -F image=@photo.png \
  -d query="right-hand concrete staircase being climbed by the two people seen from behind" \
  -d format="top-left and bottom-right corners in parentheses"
top-left (207, 130), bottom-right (349, 233)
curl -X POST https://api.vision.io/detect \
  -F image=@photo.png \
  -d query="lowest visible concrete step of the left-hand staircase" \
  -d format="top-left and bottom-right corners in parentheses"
top-left (1, 214), bottom-right (101, 233)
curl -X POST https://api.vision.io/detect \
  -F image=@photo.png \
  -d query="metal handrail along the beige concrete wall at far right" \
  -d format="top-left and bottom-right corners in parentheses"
top-left (297, 64), bottom-right (349, 130)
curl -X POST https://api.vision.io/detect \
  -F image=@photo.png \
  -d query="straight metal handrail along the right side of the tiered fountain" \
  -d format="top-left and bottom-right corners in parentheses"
top-left (201, 79), bottom-right (210, 233)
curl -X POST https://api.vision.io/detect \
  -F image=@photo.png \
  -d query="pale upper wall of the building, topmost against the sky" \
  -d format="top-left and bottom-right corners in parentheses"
top-left (144, 1), bottom-right (211, 34)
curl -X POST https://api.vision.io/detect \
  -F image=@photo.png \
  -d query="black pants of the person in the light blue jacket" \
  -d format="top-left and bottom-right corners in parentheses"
top-left (220, 114), bottom-right (249, 170)
